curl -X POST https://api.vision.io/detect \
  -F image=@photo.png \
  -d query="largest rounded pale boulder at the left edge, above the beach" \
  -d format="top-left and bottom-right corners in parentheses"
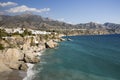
top-left (0, 48), bottom-right (24, 70)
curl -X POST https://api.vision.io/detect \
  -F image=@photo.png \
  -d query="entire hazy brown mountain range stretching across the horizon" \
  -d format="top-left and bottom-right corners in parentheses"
top-left (0, 14), bottom-right (120, 33)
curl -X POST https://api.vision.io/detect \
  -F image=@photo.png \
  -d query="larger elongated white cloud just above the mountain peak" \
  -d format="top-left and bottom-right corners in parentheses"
top-left (6, 5), bottom-right (50, 13)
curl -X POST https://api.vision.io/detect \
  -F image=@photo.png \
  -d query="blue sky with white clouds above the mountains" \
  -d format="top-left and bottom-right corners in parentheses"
top-left (0, 0), bottom-right (120, 24)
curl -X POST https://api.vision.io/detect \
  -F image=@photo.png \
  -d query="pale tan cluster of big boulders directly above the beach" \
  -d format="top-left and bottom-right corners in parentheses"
top-left (0, 48), bottom-right (40, 72)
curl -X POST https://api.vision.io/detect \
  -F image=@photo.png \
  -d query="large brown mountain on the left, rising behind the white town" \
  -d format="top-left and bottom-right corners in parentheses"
top-left (0, 14), bottom-right (72, 30)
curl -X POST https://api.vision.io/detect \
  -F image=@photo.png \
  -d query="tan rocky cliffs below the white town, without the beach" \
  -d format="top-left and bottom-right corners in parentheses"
top-left (0, 36), bottom-right (60, 72)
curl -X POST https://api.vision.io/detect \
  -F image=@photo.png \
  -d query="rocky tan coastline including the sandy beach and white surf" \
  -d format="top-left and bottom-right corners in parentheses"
top-left (0, 32), bottom-right (63, 80)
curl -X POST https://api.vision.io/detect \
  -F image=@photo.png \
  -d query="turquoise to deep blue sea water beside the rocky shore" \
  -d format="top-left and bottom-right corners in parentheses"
top-left (33, 35), bottom-right (120, 80)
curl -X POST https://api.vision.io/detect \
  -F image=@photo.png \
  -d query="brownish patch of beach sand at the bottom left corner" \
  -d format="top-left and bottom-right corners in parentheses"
top-left (0, 70), bottom-right (27, 80)
